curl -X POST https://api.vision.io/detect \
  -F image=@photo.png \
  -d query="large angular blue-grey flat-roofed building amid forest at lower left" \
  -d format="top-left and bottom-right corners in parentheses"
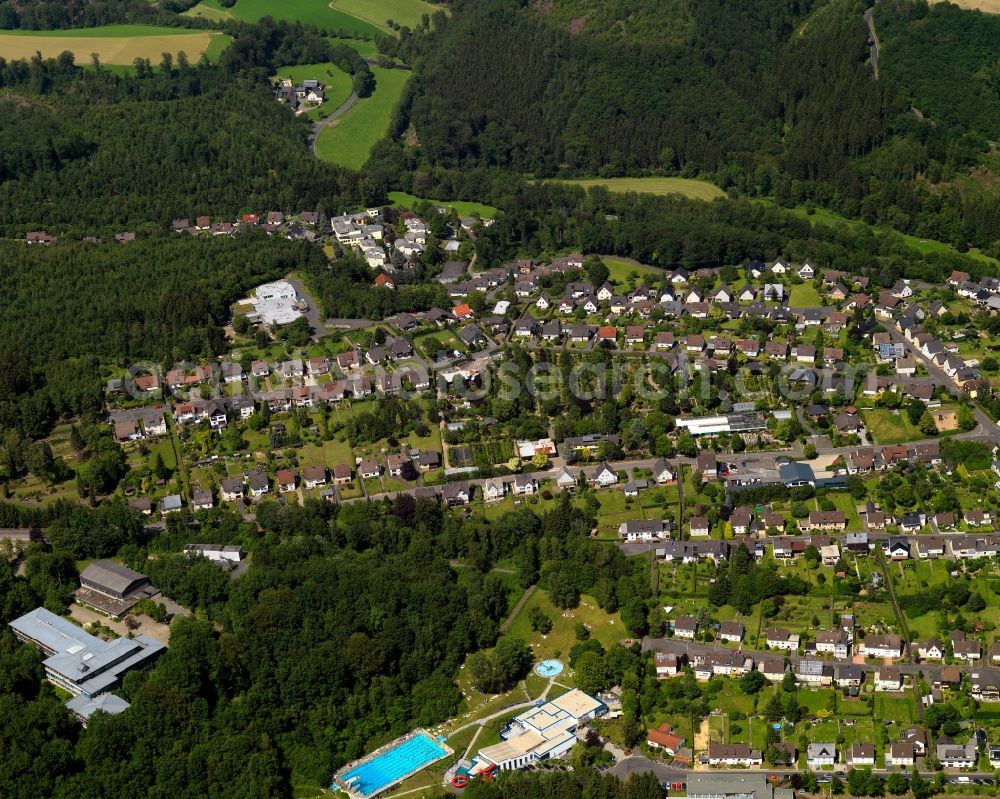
top-left (10, 608), bottom-right (166, 698)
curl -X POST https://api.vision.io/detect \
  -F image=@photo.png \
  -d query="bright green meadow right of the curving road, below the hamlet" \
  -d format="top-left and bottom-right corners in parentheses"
top-left (316, 67), bottom-right (410, 169)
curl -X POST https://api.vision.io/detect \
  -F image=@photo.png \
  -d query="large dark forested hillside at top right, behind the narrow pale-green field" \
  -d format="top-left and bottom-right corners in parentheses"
top-left (372, 0), bottom-right (1000, 254)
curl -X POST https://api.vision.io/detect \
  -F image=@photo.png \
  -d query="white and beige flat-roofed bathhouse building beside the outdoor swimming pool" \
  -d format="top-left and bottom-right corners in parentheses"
top-left (469, 688), bottom-right (607, 776)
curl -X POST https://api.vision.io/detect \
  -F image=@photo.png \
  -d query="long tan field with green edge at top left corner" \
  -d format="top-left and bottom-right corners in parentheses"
top-left (0, 25), bottom-right (230, 66)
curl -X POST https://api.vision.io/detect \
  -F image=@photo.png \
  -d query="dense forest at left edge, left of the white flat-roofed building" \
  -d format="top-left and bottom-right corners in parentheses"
top-left (0, 234), bottom-right (325, 438)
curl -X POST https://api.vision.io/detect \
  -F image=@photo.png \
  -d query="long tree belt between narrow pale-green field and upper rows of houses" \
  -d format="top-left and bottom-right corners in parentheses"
top-left (460, 178), bottom-right (989, 286)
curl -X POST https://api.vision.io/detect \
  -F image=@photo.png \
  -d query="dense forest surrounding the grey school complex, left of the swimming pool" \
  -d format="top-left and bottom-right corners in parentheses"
top-left (0, 496), bottom-right (649, 799)
